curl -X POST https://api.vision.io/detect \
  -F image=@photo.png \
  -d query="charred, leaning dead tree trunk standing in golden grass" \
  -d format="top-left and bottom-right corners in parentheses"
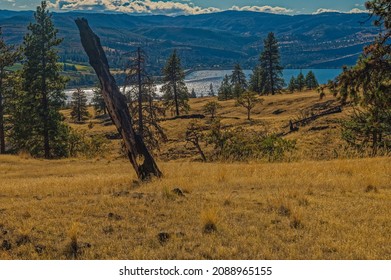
top-left (75, 18), bottom-right (162, 180)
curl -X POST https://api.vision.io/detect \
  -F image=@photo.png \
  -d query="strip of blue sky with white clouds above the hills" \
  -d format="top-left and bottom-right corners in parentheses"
top-left (0, 0), bottom-right (366, 15)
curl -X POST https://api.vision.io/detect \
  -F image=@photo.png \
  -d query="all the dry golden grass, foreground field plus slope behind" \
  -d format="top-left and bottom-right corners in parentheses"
top-left (0, 92), bottom-right (391, 259)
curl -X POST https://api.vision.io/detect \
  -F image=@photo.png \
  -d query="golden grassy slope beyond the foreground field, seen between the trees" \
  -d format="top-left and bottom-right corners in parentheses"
top-left (63, 91), bottom-right (358, 161)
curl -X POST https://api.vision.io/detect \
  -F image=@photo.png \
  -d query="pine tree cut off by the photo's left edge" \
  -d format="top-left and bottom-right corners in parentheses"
top-left (0, 27), bottom-right (19, 154)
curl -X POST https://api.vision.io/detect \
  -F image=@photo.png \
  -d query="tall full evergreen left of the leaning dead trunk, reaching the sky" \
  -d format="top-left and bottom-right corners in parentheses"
top-left (12, 1), bottom-right (68, 158)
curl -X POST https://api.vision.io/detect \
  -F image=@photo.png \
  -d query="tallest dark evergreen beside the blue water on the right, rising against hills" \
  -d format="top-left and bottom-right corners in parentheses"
top-left (259, 32), bottom-right (284, 95)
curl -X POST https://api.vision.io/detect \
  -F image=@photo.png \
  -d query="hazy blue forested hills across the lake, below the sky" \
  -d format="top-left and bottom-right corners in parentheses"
top-left (0, 10), bottom-right (378, 73)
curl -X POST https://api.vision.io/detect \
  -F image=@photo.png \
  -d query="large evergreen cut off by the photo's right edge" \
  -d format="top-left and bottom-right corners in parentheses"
top-left (337, 0), bottom-right (391, 155)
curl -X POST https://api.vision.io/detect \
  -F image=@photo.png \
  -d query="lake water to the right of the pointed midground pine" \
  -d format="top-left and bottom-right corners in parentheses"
top-left (185, 69), bottom-right (342, 95)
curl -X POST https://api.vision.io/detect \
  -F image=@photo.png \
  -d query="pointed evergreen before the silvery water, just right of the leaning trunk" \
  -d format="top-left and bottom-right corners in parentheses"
top-left (161, 50), bottom-right (190, 116)
